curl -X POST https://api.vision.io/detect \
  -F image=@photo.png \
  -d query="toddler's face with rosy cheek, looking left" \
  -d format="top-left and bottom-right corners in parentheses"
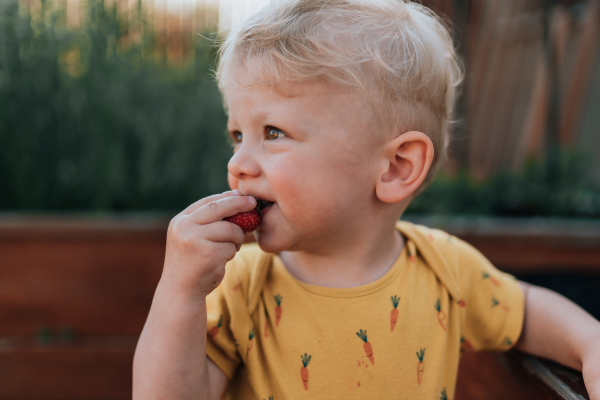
top-left (225, 69), bottom-right (390, 253)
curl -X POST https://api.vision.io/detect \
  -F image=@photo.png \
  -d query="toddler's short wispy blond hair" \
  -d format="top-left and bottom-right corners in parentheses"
top-left (217, 0), bottom-right (463, 184)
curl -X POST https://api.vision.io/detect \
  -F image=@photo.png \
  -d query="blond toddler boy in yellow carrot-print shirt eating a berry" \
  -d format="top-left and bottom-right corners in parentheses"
top-left (134, 0), bottom-right (600, 400)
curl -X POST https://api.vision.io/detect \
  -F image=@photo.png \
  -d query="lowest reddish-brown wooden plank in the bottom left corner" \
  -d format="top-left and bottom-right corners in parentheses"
top-left (0, 336), bottom-right (137, 400)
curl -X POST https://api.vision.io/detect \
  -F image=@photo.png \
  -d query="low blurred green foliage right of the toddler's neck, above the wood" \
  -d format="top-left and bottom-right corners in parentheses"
top-left (407, 149), bottom-right (600, 218)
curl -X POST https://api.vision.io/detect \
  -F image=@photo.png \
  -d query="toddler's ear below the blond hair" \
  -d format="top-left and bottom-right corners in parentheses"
top-left (375, 131), bottom-right (434, 203)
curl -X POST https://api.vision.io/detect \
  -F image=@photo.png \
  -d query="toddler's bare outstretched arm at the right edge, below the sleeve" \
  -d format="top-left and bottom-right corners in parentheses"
top-left (515, 282), bottom-right (600, 400)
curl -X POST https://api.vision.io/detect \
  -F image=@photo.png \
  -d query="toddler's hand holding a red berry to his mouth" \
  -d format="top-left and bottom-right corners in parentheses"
top-left (161, 190), bottom-right (256, 299)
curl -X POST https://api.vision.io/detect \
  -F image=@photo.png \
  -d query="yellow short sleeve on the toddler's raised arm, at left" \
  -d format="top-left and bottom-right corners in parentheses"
top-left (206, 245), bottom-right (251, 379)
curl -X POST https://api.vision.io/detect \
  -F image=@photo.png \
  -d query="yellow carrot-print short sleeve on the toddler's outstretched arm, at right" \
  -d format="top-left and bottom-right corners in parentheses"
top-left (452, 238), bottom-right (525, 351)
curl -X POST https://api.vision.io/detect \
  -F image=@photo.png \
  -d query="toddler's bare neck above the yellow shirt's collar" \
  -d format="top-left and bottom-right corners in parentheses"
top-left (279, 223), bottom-right (404, 288)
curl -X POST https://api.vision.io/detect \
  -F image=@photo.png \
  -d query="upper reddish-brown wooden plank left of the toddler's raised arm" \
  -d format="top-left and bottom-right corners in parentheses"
top-left (0, 235), bottom-right (165, 335)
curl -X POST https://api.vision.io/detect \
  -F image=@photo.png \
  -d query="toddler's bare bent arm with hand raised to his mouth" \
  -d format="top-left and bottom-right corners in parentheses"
top-left (133, 192), bottom-right (256, 400)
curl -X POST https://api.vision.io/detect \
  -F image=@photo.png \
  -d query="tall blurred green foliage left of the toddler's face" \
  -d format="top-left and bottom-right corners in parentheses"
top-left (0, 0), bottom-right (231, 211)
